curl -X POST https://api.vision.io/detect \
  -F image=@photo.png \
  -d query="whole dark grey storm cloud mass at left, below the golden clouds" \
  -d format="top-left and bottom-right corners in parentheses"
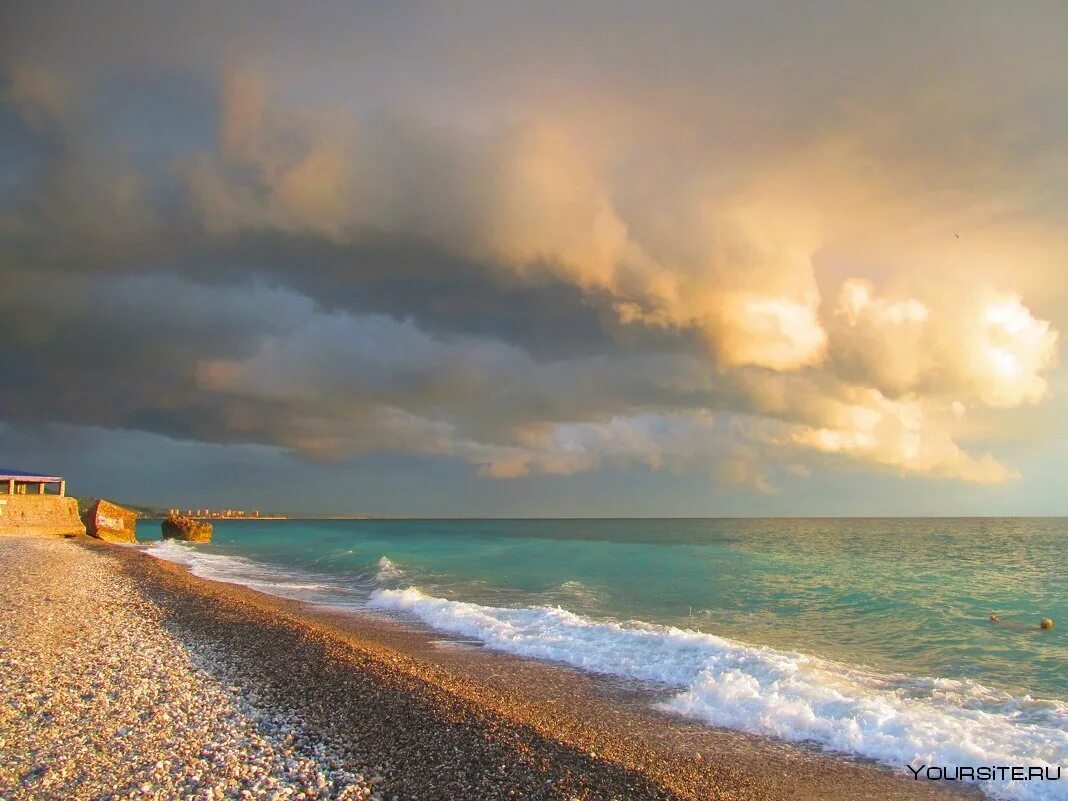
top-left (0, 59), bottom-right (726, 476)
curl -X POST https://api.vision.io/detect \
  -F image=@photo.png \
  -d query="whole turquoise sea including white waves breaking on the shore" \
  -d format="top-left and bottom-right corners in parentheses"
top-left (139, 518), bottom-right (1068, 801)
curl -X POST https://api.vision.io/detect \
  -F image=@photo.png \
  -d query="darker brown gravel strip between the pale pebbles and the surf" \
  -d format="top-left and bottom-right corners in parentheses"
top-left (71, 538), bottom-right (983, 800)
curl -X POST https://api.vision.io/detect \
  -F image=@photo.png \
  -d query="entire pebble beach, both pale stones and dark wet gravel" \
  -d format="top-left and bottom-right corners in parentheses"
top-left (0, 537), bottom-right (977, 801)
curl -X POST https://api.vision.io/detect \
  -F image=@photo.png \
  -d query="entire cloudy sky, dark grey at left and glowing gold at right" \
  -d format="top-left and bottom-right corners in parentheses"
top-left (0, 0), bottom-right (1068, 517)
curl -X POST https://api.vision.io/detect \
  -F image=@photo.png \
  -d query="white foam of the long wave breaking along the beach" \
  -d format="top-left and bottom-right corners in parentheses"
top-left (368, 587), bottom-right (1068, 801)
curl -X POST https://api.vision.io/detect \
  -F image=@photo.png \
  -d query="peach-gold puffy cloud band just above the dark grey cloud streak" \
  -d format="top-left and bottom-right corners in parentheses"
top-left (181, 75), bottom-right (827, 370)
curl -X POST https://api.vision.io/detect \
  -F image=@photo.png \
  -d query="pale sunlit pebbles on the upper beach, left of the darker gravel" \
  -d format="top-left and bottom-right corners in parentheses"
top-left (0, 537), bottom-right (371, 801)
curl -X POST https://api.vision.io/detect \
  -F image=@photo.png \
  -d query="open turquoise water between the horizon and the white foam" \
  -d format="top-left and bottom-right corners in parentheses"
top-left (142, 519), bottom-right (1068, 698)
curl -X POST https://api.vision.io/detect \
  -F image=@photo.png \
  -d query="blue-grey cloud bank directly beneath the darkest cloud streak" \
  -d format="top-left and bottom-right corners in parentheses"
top-left (0, 257), bottom-right (730, 461)
